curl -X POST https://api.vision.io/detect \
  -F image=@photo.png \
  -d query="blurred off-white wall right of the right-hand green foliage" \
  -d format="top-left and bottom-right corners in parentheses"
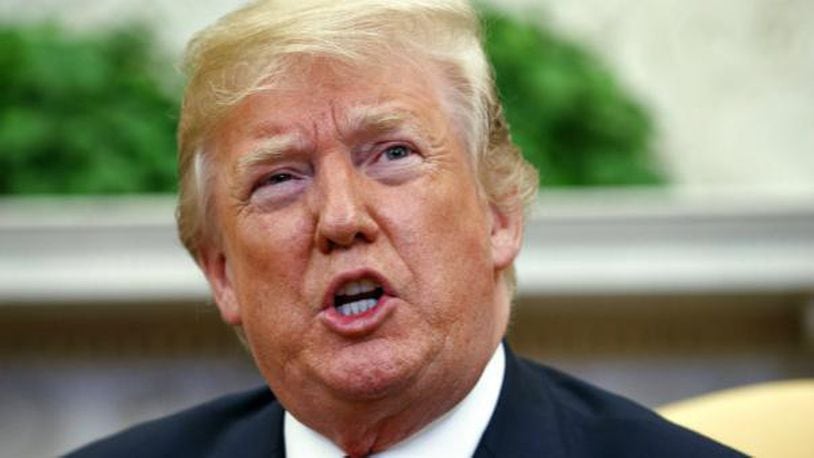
top-left (503, 0), bottom-right (814, 192)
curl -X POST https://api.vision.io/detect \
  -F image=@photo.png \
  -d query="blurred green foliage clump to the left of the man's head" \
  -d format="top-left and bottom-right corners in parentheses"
top-left (0, 24), bottom-right (178, 194)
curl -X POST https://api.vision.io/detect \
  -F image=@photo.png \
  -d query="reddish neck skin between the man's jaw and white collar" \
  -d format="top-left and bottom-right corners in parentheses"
top-left (286, 281), bottom-right (509, 458)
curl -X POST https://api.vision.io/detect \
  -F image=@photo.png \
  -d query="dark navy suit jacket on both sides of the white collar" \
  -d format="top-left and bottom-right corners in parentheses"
top-left (68, 345), bottom-right (744, 458)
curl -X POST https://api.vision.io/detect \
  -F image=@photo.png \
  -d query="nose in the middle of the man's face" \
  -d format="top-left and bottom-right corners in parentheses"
top-left (314, 157), bottom-right (378, 254)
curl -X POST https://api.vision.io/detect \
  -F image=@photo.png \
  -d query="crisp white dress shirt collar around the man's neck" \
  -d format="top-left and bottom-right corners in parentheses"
top-left (283, 343), bottom-right (506, 458)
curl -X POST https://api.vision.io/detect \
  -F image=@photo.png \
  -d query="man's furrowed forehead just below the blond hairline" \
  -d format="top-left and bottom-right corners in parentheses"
top-left (218, 58), bottom-right (450, 144)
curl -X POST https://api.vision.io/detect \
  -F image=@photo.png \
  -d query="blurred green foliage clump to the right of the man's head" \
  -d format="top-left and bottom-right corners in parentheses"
top-left (482, 9), bottom-right (664, 186)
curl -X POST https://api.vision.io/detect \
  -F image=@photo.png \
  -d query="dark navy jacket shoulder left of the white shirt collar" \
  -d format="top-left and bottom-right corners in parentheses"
top-left (67, 387), bottom-right (282, 458)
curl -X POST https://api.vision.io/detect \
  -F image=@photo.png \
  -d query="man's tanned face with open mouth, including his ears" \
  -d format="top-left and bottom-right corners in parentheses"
top-left (201, 56), bottom-right (520, 414)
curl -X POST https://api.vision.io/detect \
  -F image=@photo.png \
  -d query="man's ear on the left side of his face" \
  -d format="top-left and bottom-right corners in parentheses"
top-left (198, 243), bottom-right (242, 326)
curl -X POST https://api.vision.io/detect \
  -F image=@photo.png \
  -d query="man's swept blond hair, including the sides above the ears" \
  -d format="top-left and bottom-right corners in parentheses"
top-left (176, 0), bottom-right (537, 286)
